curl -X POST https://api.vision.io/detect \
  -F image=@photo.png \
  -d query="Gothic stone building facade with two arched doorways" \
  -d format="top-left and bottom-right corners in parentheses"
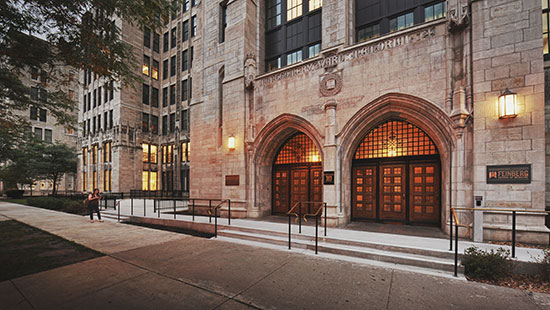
top-left (79, 0), bottom-right (549, 242)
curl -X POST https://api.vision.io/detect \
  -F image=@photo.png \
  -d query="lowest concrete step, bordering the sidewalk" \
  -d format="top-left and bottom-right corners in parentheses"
top-left (218, 228), bottom-right (463, 273)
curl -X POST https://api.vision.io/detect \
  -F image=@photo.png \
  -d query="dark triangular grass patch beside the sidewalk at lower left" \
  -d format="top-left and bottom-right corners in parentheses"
top-left (0, 221), bottom-right (103, 282)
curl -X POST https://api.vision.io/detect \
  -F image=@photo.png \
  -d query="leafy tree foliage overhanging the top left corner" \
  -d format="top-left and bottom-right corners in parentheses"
top-left (0, 0), bottom-right (172, 161)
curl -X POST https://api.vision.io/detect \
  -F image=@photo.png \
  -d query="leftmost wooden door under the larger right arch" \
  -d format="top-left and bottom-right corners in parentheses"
top-left (352, 166), bottom-right (377, 219)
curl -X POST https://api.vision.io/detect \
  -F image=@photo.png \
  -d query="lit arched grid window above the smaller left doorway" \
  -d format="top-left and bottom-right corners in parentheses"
top-left (275, 133), bottom-right (321, 165)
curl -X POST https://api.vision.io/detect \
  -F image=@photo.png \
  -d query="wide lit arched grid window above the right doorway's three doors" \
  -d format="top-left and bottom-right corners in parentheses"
top-left (355, 121), bottom-right (438, 159)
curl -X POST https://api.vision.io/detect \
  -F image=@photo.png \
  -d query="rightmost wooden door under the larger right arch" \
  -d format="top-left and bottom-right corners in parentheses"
top-left (409, 163), bottom-right (440, 224)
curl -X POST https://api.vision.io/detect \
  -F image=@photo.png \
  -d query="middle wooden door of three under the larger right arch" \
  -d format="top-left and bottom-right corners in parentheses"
top-left (379, 165), bottom-right (407, 221)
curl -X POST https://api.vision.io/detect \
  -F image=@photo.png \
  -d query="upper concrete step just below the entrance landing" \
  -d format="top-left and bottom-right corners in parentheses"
top-left (220, 226), bottom-right (461, 260)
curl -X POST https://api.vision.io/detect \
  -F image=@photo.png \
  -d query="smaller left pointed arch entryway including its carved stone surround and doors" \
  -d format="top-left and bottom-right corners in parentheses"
top-left (253, 114), bottom-right (324, 217)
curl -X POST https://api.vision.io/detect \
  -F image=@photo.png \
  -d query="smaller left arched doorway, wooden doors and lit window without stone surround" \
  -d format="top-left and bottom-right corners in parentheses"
top-left (272, 132), bottom-right (323, 214)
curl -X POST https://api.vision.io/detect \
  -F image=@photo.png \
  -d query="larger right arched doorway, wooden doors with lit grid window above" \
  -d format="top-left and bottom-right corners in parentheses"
top-left (351, 119), bottom-right (441, 225)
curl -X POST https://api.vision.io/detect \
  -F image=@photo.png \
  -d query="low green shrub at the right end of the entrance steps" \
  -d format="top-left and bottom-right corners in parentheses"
top-left (462, 246), bottom-right (510, 280)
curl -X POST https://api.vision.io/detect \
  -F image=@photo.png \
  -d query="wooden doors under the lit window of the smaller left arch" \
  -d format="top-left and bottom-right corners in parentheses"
top-left (272, 165), bottom-right (323, 214)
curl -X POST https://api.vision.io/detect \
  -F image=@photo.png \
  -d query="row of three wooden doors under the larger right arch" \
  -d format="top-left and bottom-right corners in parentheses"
top-left (352, 161), bottom-right (441, 224)
